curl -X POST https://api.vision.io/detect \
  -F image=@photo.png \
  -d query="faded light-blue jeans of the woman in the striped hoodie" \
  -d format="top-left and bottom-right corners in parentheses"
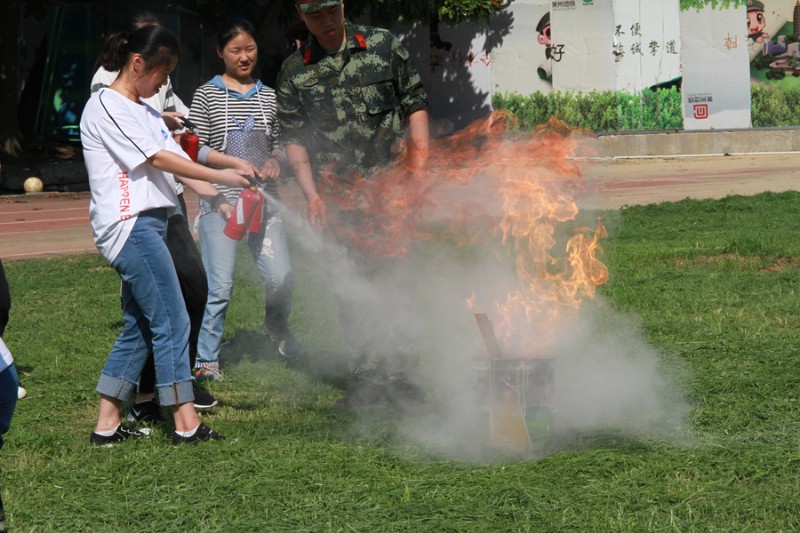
top-left (195, 205), bottom-right (293, 367)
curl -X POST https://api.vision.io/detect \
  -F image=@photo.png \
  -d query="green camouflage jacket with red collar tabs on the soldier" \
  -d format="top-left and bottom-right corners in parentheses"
top-left (276, 22), bottom-right (428, 179)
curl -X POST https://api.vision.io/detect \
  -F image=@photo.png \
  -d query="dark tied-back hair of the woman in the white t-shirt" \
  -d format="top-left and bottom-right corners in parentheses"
top-left (105, 26), bottom-right (179, 72)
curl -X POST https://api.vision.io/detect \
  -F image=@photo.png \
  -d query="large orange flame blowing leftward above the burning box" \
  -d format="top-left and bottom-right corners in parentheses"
top-left (323, 113), bottom-right (608, 356)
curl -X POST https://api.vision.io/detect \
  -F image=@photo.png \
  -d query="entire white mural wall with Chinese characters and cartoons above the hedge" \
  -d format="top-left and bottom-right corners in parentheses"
top-left (482, 0), bottom-right (800, 130)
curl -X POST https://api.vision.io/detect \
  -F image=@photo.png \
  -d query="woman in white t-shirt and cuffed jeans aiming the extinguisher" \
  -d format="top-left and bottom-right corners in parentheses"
top-left (81, 22), bottom-right (252, 445)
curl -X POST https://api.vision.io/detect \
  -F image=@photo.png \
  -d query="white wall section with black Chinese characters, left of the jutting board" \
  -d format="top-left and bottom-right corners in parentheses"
top-left (492, 0), bottom-right (681, 93)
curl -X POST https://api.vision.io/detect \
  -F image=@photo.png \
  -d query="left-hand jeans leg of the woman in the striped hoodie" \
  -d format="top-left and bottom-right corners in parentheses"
top-left (195, 207), bottom-right (237, 368)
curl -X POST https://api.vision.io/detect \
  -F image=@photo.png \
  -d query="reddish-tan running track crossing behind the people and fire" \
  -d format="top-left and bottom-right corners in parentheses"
top-left (0, 153), bottom-right (800, 261)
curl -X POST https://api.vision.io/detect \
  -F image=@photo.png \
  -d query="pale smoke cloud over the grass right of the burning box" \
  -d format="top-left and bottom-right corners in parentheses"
top-left (553, 299), bottom-right (690, 440)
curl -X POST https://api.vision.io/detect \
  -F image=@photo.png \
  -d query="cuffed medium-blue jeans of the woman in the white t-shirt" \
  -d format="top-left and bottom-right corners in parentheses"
top-left (97, 209), bottom-right (194, 406)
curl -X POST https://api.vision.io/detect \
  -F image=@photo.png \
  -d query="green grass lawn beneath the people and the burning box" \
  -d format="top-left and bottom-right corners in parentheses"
top-left (0, 193), bottom-right (800, 532)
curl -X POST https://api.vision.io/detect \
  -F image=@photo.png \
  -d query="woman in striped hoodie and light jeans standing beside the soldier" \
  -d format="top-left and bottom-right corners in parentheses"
top-left (189, 18), bottom-right (300, 380)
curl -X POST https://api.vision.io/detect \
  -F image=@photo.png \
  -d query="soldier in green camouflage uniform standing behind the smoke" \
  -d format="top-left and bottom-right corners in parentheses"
top-left (276, 0), bottom-right (428, 401)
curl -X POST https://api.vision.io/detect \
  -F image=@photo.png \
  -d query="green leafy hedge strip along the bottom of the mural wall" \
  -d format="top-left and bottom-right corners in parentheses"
top-left (492, 84), bottom-right (800, 132)
